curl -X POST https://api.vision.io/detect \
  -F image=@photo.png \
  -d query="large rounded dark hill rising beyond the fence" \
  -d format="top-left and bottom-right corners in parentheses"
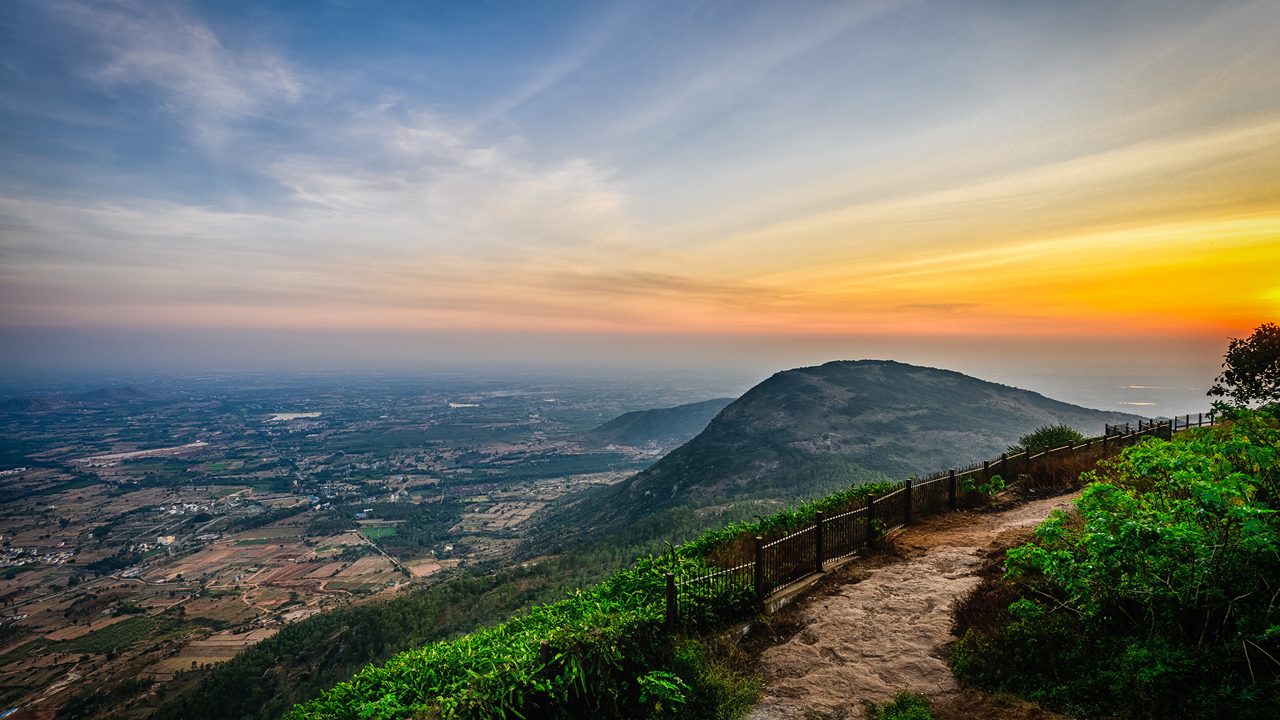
top-left (527, 360), bottom-right (1138, 547)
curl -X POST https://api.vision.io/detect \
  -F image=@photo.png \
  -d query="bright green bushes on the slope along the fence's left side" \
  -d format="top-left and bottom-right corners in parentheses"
top-left (288, 476), bottom-right (906, 720)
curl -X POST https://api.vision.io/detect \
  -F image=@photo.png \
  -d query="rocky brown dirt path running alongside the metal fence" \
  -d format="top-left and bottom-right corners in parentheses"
top-left (748, 495), bottom-right (1075, 720)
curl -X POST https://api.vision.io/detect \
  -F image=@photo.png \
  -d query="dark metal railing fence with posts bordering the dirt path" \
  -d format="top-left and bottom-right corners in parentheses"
top-left (666, 413), bottom-right (1217, 628)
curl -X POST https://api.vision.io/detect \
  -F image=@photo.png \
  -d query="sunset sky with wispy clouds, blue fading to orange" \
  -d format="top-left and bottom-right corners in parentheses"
top-left (0, 0), bottom-right (1280, 404)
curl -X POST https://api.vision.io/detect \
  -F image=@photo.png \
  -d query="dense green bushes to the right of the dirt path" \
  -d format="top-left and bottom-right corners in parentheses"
top-left (951, 413), bottom-right (1280, 719)
